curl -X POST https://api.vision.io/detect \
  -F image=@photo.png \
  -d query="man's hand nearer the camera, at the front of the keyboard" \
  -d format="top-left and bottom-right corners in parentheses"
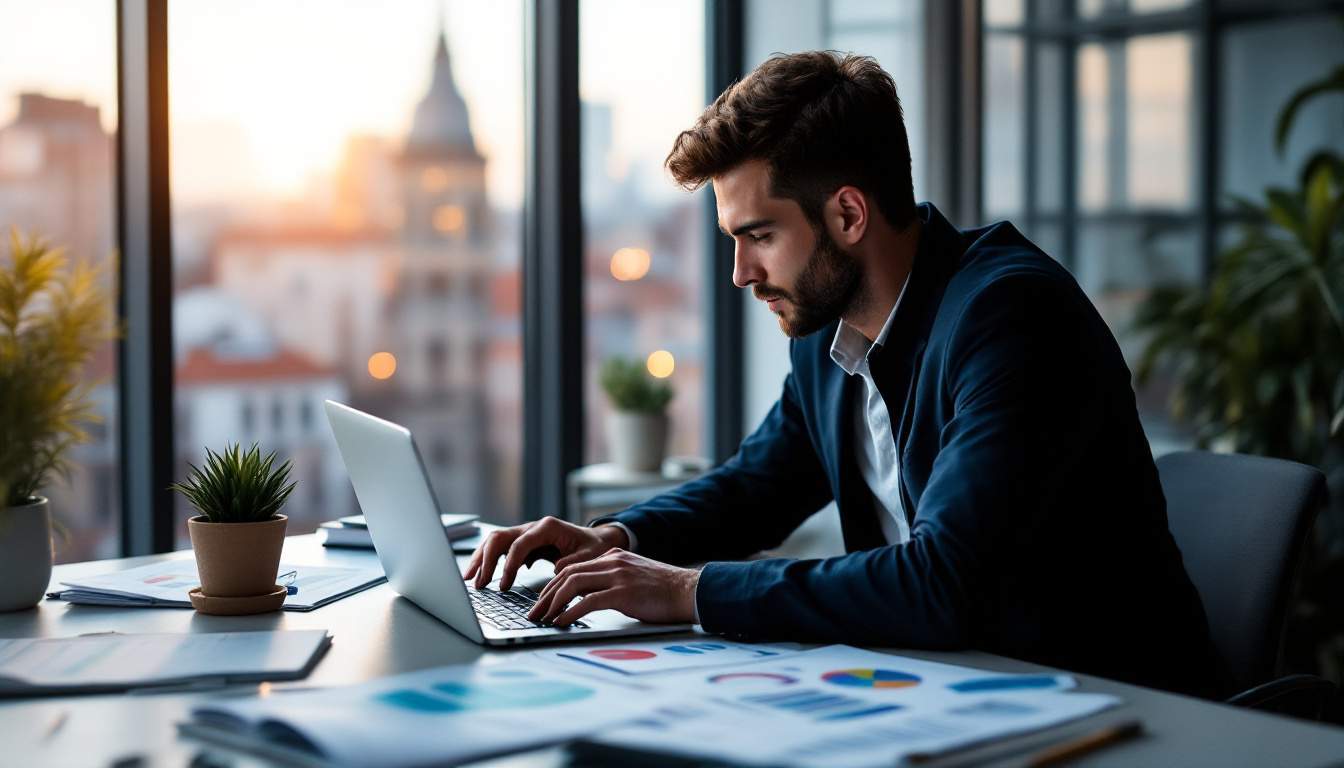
top-left (527, 549), bottom-right (700, 627)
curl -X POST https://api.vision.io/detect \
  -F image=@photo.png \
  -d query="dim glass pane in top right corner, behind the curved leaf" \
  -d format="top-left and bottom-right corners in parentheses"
top-left (1219, 16), bottom-right (1344, 203)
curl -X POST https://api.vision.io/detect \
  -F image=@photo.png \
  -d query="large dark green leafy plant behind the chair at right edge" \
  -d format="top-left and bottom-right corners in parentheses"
top-left (1136, 48), bottom-right (1344, 681)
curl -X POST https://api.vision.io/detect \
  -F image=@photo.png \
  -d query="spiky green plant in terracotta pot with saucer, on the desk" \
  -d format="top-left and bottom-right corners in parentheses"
top-left (171, 443), bottom-right (294, 613)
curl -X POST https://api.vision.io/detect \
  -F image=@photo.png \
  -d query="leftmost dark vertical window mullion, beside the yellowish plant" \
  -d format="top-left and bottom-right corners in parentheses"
top-left (117, 0), bottom-right (173, 555)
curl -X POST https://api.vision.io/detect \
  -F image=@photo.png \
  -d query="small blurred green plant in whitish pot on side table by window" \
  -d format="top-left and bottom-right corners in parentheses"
top-left (598, 358), bottom-right (672, 472)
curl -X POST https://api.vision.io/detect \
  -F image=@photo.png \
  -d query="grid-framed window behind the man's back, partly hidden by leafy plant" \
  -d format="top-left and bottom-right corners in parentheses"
top-left (981, 0), bottom-right (1344, 451)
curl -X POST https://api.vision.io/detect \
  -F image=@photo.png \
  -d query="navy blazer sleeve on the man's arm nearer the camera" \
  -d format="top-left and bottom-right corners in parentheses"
top-left (696, 276), bottom-right (1095, 648)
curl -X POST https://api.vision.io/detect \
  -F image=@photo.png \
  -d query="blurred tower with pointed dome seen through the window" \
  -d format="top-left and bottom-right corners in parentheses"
top-left (388, 17), bottom-right (492, 514)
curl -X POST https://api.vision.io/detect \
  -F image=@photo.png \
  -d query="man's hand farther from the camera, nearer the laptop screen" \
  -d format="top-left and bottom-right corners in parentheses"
top-left (464, 518), bottom-right (630, 590)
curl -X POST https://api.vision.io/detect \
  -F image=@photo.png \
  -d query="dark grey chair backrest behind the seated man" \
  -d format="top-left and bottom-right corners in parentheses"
top-left (1157, 451), bottom-right (1327, 693)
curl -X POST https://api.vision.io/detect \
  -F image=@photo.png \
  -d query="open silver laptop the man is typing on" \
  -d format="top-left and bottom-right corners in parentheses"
top-left (325, 399), bottom-right (691, 646)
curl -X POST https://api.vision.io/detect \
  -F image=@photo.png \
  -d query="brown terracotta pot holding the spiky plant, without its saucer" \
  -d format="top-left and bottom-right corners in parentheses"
top-left (187, 515), bottom-right (289, 597)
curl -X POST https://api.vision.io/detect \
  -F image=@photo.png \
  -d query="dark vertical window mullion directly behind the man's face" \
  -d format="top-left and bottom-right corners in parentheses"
top-left (702, 0), bottom-right (746, 463)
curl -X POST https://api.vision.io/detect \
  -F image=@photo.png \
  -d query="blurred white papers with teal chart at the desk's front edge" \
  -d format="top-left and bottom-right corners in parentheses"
top-left (181, 662), bottom-right (652, 767)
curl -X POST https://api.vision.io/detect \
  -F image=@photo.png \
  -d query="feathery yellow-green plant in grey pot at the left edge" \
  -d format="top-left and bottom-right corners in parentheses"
top-left (0, 229), bottom-right (116, 611)
